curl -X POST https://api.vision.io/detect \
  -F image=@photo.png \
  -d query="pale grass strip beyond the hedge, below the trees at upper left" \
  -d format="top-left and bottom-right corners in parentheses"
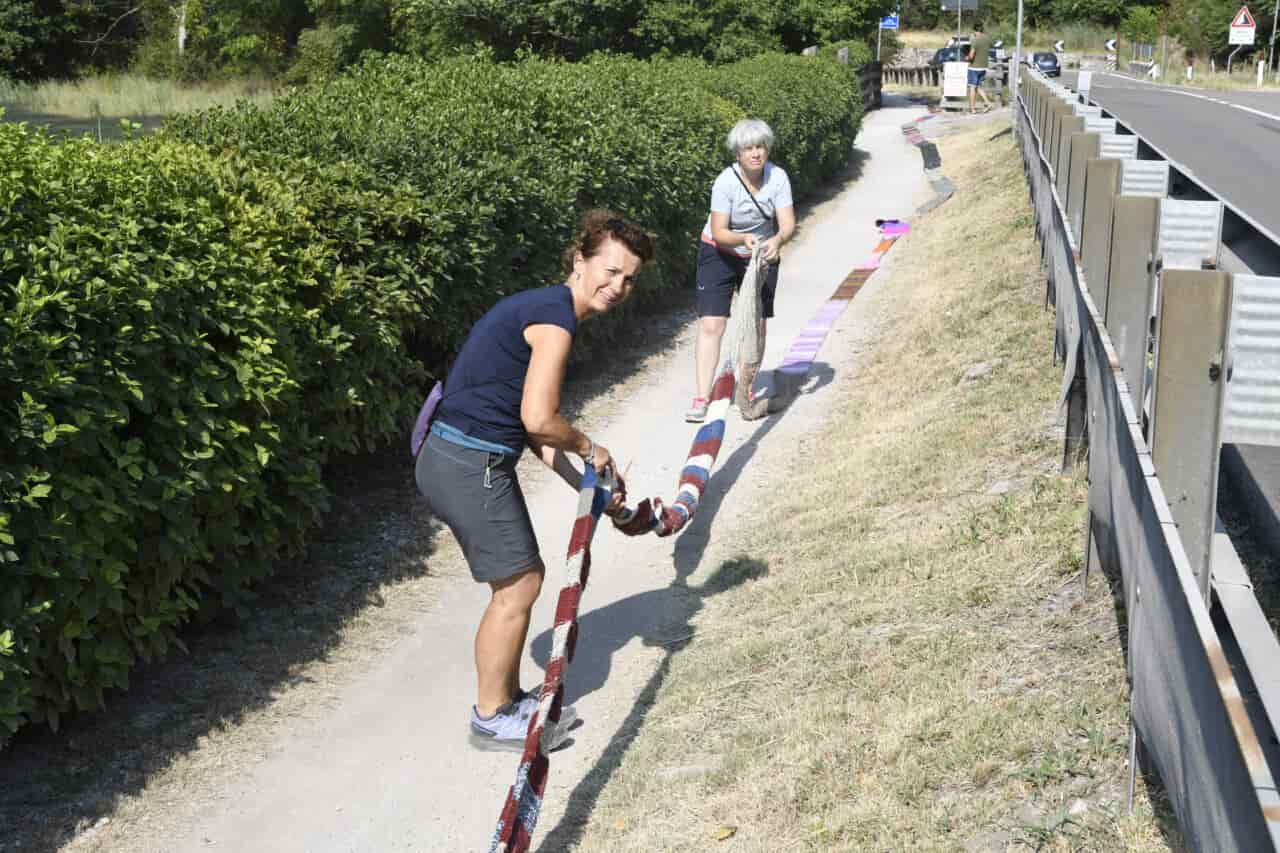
top-left (0, 74), bottom-right (275, 119)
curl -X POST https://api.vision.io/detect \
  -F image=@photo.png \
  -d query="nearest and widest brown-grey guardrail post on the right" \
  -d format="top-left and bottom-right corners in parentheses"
top-left (1151, 269), bottom-right (1231, 603)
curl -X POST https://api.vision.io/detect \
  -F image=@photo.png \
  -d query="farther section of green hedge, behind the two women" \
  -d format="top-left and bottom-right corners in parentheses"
top-left (169, 54), bottom-right (860, 352)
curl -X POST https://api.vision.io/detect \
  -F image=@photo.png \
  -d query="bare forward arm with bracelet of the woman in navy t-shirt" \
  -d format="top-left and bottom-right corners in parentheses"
top-left (520, 323), bottom-right (613, 470)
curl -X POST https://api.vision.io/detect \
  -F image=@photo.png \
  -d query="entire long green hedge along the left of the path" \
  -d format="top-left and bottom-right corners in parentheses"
top-left (0, 55), bottom-right (860, 730)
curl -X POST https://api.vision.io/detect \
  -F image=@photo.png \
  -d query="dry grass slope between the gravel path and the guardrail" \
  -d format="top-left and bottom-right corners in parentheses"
top-left (577, 124), bottom-right (1176, 852)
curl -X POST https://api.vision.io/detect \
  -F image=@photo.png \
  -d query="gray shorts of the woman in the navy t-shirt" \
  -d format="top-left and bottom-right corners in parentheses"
top-left (415, 433), bottom-right (541, 583)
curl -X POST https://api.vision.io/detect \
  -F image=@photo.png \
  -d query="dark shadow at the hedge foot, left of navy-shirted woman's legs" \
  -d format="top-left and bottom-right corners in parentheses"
top-left (0, 446), bottom-right (439, 853)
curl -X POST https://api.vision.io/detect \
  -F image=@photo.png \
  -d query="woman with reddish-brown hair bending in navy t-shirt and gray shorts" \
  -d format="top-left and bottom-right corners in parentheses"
top-left (415, 210), bottom-right (653, 751)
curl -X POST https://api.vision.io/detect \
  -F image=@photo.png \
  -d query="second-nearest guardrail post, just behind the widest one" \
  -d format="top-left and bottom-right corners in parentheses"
top-left (1098, 196), bottom-right (1160, 404)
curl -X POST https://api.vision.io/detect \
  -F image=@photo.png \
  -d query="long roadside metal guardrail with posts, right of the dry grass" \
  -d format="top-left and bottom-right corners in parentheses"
top-left (1015, 69), bottom-right (1280, 852)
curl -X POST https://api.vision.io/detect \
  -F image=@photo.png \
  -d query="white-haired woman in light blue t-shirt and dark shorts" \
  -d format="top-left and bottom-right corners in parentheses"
top-left (685, 119), bottom-right (796, 423)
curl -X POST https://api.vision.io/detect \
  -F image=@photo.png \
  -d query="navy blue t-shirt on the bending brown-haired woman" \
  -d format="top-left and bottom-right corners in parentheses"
top-left (436, 284), bottom-right (577, 453)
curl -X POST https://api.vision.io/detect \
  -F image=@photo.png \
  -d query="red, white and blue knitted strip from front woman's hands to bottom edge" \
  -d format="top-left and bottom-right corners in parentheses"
top-left (489, 465), bottom-right (614, 853)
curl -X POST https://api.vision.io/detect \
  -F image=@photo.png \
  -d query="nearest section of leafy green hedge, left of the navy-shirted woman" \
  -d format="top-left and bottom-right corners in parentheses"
top-left (0, 124), bottom-right (422, 729)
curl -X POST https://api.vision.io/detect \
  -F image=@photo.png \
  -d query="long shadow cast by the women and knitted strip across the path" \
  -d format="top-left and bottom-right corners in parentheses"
top-left (532, 361), bottom-right (836, 853)
